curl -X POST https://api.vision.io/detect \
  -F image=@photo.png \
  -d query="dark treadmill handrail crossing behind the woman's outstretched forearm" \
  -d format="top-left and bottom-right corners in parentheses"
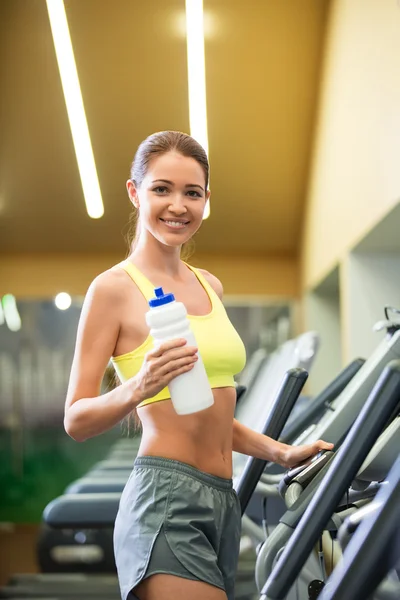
top-left (236, 368), bottom-right (308, 515)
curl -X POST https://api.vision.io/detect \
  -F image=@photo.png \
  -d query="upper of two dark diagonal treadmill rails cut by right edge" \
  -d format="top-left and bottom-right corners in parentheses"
top-left (261, 360), bottom-right (400, 600)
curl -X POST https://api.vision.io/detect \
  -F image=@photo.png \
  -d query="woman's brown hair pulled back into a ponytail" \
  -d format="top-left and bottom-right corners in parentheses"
top-left (127, 131), bottom-right (209, 258)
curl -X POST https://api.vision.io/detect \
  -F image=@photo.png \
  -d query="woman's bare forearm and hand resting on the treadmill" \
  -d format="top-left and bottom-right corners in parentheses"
top-left (233, 419), bottom-right (333, 467)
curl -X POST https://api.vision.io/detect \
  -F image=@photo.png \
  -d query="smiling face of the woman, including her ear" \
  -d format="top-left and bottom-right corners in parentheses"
top-left (127, 152), bottom-right (210, 246)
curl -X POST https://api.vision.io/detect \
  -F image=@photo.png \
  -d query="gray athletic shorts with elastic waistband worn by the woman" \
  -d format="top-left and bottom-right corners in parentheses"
top-left (114, 456), bottom-right (241, 600)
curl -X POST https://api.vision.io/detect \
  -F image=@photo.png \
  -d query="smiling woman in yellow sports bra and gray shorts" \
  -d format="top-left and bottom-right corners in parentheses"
top-left (65, 131), bottom-right (332, 600)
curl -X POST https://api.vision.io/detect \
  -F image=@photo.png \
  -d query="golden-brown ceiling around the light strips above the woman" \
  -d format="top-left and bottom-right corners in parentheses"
top-left (0, 0), bottom-right (328, 255)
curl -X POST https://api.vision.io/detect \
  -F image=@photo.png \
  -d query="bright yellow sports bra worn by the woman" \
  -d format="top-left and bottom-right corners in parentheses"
top-left (111, 260), bottom-right (246, 408)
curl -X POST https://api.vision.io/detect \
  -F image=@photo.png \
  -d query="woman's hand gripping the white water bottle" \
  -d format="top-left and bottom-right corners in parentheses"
top-left (135, 339), bottom-right (198, 403)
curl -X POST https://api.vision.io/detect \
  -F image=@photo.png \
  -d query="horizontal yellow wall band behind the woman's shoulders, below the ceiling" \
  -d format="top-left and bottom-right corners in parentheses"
top-left (0, 254), bottom-right (299, 298)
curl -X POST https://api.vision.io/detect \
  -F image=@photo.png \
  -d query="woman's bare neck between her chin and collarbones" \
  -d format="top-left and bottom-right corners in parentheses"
top-left (129, 231), bottom-right (182, 277)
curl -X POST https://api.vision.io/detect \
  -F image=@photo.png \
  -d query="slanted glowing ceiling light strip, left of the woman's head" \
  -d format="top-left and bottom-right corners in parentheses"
top-left (46, 0), bottom-right (104, 219)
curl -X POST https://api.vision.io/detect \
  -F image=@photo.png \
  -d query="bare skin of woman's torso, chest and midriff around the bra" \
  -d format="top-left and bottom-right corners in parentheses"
top-left (114, 265), bottom-right (236, 479)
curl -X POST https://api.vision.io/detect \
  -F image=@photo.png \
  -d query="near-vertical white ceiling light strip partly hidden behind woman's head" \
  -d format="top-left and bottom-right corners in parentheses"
top-left (186, 0), bottom-right (210, 219)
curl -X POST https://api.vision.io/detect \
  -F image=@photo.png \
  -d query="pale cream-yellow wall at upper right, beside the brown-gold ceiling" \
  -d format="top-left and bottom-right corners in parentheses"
top-left (301, 0), bottom-right (400, 288)
